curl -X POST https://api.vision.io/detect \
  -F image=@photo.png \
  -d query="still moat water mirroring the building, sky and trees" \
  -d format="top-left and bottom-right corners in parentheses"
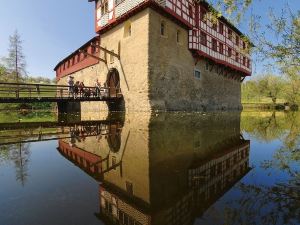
top-left (0, 112), bottom-right (300, 225)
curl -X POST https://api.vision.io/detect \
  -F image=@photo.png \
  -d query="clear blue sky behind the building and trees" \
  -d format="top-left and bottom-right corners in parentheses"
top-left (0, 0), bottom-right (300, 78)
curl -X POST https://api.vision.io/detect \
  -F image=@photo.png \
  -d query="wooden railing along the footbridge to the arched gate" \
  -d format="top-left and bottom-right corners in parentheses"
top-left (0, 83), bottom-right (122, 99)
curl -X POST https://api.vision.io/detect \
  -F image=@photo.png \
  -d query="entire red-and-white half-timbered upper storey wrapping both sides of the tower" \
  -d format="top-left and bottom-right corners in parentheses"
top-left (89, 0), bottom-right (252, 77)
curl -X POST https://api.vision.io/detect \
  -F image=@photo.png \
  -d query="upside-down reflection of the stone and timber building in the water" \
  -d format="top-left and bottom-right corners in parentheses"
top-left (58, 112), bottom-right (250, 225)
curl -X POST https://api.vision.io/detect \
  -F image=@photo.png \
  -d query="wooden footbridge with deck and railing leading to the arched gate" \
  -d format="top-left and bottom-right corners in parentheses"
top-left (0, 83), bottom-right (122, 103)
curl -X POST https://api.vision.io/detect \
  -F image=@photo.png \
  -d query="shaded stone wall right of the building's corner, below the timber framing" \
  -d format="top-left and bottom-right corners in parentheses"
top-left (149, 10), bottom-right (241, 111)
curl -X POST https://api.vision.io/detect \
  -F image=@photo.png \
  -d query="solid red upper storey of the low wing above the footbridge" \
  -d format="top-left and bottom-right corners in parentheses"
top-left (54, 36), bottom-right (100, 80)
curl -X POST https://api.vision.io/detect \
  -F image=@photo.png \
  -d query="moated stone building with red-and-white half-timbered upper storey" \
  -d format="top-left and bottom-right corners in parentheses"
top-left (55, 0), bottom-right (252, 111)
